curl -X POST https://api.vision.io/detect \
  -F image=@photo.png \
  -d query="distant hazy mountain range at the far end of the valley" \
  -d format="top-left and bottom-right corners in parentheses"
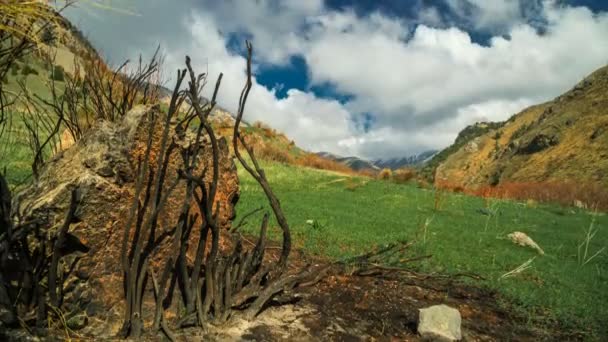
top-left (317, 150), bottom-right (438, 171)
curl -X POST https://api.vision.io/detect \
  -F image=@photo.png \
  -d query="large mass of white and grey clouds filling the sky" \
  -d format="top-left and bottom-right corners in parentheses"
top-left (83, 0), bottom-right (608, 158)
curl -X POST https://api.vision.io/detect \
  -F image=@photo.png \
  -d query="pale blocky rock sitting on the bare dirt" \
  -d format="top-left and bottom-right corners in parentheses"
top-left (418, 304), bottom-right (462, 341)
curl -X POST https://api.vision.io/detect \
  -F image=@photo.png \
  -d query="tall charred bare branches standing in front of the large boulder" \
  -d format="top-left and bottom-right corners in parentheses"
top-left (116, 43), bottom-right (315, 339)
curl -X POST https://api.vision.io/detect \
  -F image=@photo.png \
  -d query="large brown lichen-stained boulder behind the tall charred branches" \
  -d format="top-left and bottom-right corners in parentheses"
top-left (15, 106), bottom-right (239, 328)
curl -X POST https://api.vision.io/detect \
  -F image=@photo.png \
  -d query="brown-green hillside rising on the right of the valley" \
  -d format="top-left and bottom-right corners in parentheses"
top-left (424, 66), bottom-right (608, 188)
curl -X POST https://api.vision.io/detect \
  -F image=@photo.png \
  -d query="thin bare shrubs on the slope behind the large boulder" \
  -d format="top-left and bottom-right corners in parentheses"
top-left (16, 49), bottom-right (163, 179)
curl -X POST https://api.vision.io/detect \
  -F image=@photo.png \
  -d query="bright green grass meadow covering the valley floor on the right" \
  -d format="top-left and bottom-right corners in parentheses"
top-left (237, 163), bottom-right (608, 339)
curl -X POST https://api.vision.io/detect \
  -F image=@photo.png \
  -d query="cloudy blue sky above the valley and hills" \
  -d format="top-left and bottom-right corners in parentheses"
top-left (65, 0), bottom-right (608, 159)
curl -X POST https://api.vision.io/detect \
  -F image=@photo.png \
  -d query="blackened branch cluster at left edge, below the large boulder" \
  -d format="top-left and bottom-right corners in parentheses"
top-left (0, 175), bottom-right (88, 331)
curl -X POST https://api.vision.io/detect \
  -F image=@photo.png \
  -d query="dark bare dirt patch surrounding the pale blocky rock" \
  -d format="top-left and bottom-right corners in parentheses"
top-left (1, 246), bottom-right (560, 341)
